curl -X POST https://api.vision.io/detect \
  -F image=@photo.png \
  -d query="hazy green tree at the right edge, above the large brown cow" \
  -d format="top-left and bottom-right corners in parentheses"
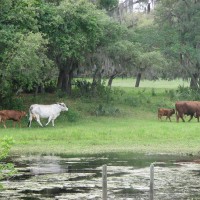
top-left (156, 0), bottom-right (200, 88)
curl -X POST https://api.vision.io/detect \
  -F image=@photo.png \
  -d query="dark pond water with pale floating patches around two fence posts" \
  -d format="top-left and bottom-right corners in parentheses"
top-left (0, 153), bottom-right (200, 200)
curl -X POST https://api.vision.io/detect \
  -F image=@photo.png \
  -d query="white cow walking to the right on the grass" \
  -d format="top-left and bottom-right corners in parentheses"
top-left (28, 103), bottom-right (68, 127)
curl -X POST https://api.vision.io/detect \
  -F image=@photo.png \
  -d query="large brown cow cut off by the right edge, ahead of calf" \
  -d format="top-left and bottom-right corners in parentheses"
top-left (175, 101), bottom-right (200, 122)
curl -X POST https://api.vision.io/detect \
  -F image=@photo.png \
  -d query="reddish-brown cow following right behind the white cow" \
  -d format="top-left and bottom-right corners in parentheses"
top-left (0, 110), bottom-right (26, 128)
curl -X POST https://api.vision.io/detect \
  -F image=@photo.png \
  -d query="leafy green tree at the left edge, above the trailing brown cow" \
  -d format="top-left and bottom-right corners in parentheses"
top-left (0, 0), bottom-right (52, 100)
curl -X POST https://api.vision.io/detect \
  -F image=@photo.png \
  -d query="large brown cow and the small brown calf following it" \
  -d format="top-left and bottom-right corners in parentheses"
top-left (158, 101), bottom-right (200, 122)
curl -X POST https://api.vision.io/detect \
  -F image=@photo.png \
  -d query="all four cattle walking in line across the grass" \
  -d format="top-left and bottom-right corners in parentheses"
top-left (0, 101), bottom-right (200, 128)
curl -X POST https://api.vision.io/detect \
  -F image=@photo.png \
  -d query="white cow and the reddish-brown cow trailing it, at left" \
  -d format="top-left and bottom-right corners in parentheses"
top-left (0, 103), bottom-right (68, 128)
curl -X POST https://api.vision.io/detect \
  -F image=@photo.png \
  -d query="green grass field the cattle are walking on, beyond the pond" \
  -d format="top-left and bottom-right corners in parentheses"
top-left (0, 79), bottom-right (200, 154)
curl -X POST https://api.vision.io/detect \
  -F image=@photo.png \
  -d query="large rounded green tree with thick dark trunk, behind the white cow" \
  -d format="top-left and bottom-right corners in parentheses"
top-left (40, 0), bottom-right (124, 94)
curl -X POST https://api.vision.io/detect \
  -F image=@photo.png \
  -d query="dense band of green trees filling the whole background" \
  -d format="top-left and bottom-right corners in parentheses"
top-left (0, 0), bottom-right (200, 106)
